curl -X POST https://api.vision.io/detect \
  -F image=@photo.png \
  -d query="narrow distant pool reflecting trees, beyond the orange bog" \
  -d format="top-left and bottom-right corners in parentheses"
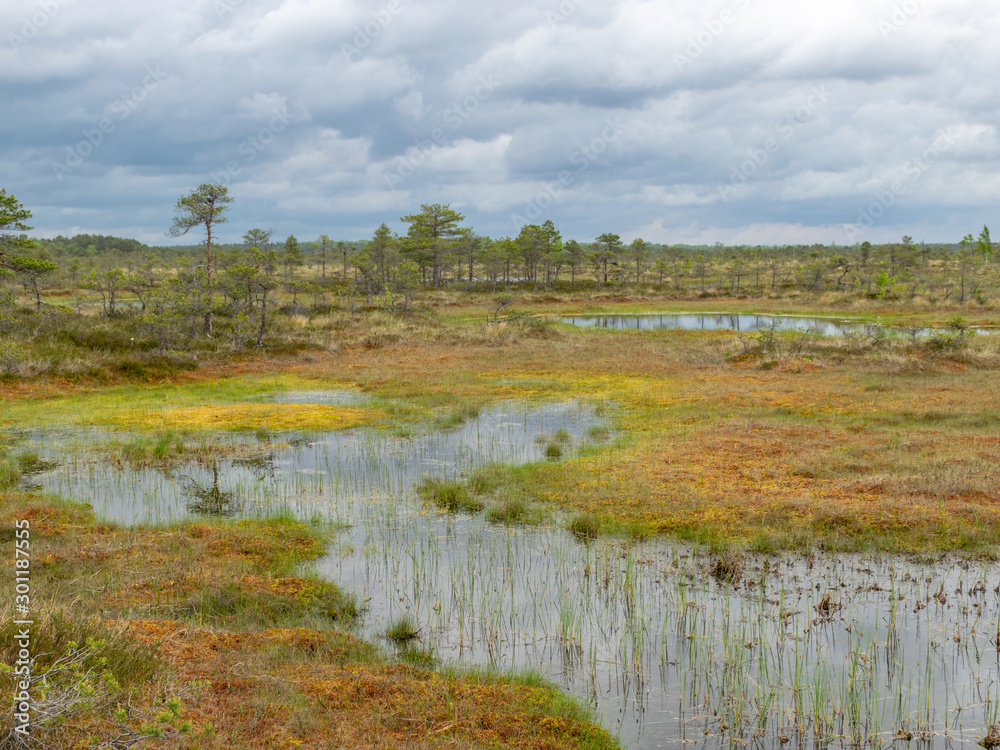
top-left (562, 313), bottom-right (991, 336)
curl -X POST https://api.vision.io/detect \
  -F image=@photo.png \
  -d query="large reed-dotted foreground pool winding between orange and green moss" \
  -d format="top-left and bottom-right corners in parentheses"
top-left (17, 393), bottom-right (1000, 749)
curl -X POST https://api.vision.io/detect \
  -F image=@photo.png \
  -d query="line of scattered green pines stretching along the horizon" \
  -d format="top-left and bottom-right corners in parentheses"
top-left (0, 184), bottom-right (1000, 346)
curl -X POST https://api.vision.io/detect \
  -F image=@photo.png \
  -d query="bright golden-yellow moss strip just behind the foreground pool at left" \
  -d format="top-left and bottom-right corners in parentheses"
top-left (107, 404), bottom-right (381, 431)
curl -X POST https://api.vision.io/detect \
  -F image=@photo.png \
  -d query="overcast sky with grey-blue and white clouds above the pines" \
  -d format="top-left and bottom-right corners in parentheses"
top-left (0, 0), bottom-right (1000, 245)
